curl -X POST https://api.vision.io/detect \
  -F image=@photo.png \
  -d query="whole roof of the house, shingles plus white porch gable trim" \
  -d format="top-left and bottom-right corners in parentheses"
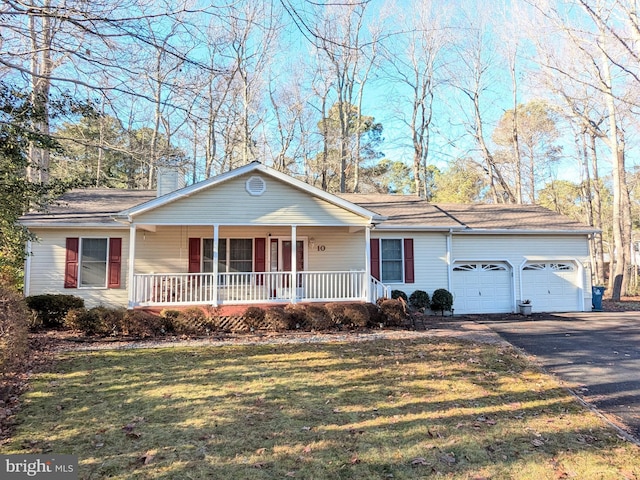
top-left (20, 162), bottom-right (596, 234)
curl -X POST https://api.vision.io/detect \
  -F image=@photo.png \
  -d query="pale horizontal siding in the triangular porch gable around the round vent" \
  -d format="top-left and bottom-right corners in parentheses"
top-left (135, 175), bottom-right (368, 225)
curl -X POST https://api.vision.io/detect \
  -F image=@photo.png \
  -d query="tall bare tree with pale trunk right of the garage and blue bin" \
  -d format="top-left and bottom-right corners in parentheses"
top-left (536, 0), bottom-right (637, 300)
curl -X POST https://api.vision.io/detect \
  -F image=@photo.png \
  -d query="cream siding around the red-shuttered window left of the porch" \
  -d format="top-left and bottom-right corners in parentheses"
top-left (29, 229), bottom-right (129, 307)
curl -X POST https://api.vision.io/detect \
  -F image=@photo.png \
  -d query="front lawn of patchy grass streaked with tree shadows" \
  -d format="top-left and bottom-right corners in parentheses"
top-left (3, 339), bottom-right (640, 480)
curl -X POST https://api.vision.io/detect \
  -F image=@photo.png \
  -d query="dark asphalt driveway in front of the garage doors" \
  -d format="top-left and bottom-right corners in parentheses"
top-left (482, 312), bottom-right (640, 443)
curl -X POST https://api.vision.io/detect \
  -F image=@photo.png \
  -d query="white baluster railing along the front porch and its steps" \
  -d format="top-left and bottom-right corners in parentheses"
top-left (132, 270), bottom-right (389, 306)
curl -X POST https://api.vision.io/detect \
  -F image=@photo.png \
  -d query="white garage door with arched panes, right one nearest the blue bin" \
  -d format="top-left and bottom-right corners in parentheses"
top-left (522, 262), bottom-right (580, 312)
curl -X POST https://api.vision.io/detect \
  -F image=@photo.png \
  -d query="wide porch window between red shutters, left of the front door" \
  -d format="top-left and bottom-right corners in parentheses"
top-left (202, 238), bottom-right (253, 273)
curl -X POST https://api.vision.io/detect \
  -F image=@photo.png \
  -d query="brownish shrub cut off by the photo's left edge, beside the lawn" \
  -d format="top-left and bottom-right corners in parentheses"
top-left (0, 287), bottom-right (29, 376)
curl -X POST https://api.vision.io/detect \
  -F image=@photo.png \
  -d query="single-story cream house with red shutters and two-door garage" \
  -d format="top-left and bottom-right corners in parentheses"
top-left (21, 162), bottom-right (594, 314)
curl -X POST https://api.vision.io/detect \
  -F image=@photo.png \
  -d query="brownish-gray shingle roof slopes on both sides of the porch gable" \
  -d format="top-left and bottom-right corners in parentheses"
top-left (21, 189), bottom-right (593, 233)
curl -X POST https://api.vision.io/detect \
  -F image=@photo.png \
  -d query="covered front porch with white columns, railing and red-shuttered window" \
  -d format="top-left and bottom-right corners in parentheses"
top-left (128, 225), bottom-right (390, 308)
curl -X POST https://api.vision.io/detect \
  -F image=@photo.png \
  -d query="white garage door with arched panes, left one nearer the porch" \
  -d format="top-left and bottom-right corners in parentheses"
top-left (451, 262), bottom-right (513, 313)
